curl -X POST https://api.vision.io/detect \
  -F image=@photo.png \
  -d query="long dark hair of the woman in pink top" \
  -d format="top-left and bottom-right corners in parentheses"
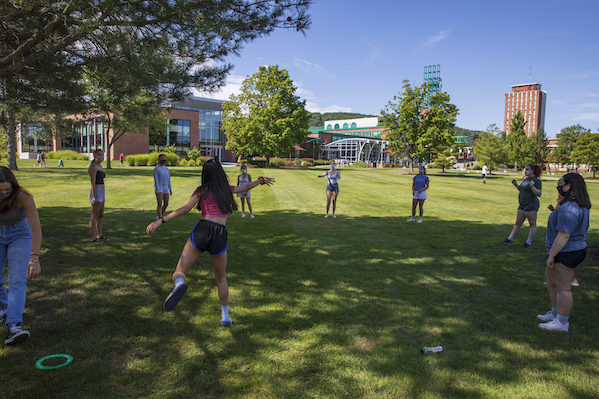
top-left (194, 159), bottom-right (237, 213)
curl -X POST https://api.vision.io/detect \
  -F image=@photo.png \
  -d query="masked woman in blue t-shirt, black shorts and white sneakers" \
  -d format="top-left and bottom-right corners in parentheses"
top-left (537, 173), bottom-right (591, 331)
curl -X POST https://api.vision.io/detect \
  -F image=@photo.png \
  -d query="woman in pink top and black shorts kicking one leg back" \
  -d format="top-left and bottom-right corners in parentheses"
top-left (146, 159), bottom-right (274, 326)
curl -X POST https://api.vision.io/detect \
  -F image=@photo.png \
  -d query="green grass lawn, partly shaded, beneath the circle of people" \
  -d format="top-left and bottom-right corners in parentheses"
top-left (0, 161), bottom-right (599, 399)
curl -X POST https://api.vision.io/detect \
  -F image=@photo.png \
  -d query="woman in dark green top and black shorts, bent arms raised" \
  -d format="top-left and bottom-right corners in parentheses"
top-left (502, 165), bottom-right (541, 248)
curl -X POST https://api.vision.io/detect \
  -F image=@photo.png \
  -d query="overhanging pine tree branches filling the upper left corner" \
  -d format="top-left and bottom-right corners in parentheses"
top-left (0, 0), bottom-right (311, 169)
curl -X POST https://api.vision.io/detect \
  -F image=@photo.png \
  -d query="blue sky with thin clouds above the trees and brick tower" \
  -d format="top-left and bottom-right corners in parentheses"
top-left (195, 0), bottom-right (599, 137)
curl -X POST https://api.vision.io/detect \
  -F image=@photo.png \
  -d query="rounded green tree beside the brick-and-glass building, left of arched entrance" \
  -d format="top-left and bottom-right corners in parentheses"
top-left (222, 65), bottom-right (310, 165)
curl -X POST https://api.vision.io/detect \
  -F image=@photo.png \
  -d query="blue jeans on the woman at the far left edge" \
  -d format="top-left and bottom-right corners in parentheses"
top-left (0, 219), bottom-right (31, 325)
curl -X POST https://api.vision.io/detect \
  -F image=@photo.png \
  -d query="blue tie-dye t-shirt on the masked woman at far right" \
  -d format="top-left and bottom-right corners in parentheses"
top-left (545, 201), bottom-right (589, 253)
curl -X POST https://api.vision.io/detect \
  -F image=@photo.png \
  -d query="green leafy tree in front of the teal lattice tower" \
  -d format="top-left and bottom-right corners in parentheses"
top-left (381, 80), bottom-right (458, 173)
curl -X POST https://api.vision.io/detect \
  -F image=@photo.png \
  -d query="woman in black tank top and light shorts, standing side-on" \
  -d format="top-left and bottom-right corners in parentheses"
top-left (87, 149), bottom-right (106, 242)
